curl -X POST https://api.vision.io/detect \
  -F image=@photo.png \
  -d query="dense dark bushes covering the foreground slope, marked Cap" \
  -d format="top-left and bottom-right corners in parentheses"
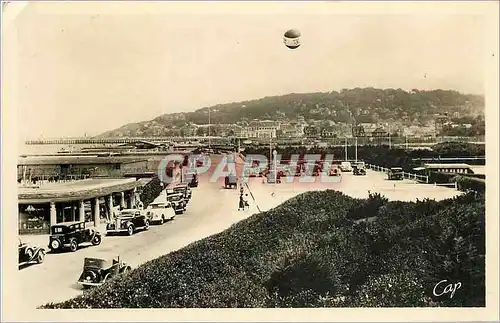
top-left (44, 191), bottom-right (485, 308)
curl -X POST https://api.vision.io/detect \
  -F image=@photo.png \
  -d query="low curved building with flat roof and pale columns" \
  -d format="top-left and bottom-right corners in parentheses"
top-left (18, 178), bottom-right (149, 234)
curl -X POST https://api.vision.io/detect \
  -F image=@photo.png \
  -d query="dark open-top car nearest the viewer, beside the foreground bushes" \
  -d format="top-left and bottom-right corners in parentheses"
top-left (78, 257), bottom-right (132, 288)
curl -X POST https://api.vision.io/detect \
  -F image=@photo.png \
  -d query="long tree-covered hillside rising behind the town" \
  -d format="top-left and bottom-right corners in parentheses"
top-left (99, 88), bottom-right (484, 137)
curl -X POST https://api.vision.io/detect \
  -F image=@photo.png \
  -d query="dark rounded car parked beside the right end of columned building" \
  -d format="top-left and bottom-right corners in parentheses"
top-left (106, 209), bottom-right (149, 236)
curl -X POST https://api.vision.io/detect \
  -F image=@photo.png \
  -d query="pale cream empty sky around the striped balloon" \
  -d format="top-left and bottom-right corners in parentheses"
top-left (6, 3), bottom-right (492, 139)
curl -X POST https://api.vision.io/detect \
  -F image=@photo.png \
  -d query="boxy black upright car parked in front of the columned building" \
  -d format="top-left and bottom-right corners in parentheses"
top-left (49, 221), bottom-right (102, 252)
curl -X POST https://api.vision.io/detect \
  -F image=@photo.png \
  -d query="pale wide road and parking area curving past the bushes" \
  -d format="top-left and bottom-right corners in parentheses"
top-left (18, 157), bottom-right (457, 310)
